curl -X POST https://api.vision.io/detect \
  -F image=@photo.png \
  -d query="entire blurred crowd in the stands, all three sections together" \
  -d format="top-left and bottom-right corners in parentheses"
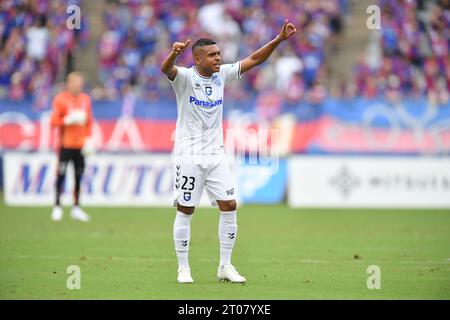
top-left (0, 0), bottom-right (450, 109)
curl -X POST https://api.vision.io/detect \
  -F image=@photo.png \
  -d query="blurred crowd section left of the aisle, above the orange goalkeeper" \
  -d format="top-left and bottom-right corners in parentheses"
top-left (0, 0), bottom-right (88, 109)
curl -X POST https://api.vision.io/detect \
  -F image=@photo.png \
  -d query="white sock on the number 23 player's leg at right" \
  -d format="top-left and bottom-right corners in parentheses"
top-left (219, 210), bottom-right (237, 266)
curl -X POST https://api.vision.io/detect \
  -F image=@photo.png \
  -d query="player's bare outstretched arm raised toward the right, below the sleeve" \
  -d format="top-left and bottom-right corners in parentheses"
top-left (241, 19), bottom-right (297, 73)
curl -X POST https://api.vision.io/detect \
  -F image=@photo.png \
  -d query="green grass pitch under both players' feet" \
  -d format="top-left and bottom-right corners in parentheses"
top-left (0, 203), bottom-right (450, 300)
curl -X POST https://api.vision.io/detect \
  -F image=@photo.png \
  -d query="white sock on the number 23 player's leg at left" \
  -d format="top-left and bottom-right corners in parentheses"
top-left (173, 211), bottom-right (192, 268)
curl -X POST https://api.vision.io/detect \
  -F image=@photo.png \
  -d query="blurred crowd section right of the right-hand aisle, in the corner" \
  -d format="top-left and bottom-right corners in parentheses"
top-left (352, 0), bottom-right (450, 103)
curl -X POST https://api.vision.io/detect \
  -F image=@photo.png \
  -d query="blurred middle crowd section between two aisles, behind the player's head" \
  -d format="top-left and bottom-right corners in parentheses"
top-left (95, 0), bottom-right (349, 100)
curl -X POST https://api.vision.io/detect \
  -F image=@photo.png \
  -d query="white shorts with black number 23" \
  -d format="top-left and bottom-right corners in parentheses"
top-left (173, 154), bottom-right (235, 207)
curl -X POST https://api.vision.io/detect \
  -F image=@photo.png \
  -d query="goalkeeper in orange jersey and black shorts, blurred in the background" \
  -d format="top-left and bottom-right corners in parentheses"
top-left (50, 72), bottom-right (93, 222)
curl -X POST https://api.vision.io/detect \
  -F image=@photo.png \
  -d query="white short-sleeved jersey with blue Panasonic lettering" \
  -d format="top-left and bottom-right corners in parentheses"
top-left (171, 62), bottom-right (241, 155)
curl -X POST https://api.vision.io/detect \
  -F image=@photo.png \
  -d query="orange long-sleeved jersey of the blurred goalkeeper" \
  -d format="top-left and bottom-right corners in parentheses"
top-left (50, 91), bottom-right (93, 149)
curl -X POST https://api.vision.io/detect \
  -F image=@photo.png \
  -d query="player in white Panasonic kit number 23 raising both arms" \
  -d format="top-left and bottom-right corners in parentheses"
top-left (161, 20), bottom-right (296, 283)
